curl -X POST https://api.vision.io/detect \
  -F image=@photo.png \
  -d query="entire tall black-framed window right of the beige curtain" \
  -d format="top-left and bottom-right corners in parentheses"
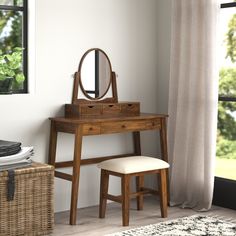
top-left (213, 0), bottom-right (236, 209)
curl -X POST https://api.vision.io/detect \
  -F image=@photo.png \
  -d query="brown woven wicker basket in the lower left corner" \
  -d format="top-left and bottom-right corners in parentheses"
top-left (0, 163), bottom-right (54, 236)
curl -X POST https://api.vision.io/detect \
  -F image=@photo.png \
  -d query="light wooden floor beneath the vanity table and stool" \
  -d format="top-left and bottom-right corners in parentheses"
top-left (53, 197), bottom-right (236, 236)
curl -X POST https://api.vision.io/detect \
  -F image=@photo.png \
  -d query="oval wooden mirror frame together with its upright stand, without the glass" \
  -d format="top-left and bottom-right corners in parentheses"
top-left (72, 48), bottom-right (118, 104)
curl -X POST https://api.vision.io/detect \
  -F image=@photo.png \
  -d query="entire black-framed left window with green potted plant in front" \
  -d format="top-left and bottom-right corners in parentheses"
top-left (0, 0), bottom-right (27, 93)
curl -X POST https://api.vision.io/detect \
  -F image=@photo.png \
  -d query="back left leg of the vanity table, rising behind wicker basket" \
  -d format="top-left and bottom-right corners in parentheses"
top-left (48, 121), bottom-right (57, 166)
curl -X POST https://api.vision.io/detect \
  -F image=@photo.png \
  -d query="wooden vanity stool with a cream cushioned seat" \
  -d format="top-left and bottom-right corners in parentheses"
top-left (98, 156), bottom-right (169, 226)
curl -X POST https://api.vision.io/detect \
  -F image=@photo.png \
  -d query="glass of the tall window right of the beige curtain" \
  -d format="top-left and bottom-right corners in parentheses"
top-left (216, 5), bottom-right (236, 180)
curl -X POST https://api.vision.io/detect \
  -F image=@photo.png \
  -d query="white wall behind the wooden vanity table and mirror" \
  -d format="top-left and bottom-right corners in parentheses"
top-left (0, 0), bottom-right (171, 211)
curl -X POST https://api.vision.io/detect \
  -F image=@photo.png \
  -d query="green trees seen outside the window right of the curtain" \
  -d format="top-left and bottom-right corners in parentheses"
top-left (217, 10), bottom-right (236, 160)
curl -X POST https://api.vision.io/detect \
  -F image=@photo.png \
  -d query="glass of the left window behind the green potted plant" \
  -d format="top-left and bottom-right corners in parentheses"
top-left (0, 10), bottom-right (23, 91)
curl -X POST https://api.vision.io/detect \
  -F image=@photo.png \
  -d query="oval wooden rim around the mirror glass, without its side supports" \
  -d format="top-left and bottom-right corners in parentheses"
top-left (78, 48), bottom-right (112, 100)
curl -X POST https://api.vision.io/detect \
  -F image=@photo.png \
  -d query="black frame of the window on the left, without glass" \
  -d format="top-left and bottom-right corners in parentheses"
top-left (0, 0), bottom-right (28, 94)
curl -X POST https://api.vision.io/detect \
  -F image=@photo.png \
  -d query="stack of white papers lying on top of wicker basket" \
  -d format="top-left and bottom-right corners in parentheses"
top-left (0, 147), bottom-right (34, 171)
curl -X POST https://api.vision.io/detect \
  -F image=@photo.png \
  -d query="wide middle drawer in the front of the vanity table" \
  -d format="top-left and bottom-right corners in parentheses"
top-left (101, 121), bottom-right (147, 134)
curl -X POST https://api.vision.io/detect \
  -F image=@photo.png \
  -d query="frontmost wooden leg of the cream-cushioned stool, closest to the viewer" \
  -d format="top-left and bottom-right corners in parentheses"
top-left (121, 175), bottom-right (130, 226)
